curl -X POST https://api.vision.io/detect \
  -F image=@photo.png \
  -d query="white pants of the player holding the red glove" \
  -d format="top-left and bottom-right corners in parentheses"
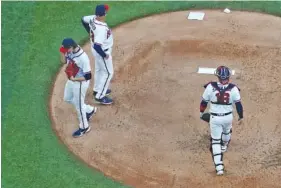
top-left (64, 80), bottom-right (94, 129)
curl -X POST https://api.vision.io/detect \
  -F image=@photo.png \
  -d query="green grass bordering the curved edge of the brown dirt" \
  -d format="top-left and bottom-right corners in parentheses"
top-left (1, 1), bottom-right (281, 188)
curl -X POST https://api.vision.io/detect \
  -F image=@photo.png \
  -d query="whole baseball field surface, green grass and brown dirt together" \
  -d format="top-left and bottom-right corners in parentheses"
top-left (1, 1), bottom-right (281, 188)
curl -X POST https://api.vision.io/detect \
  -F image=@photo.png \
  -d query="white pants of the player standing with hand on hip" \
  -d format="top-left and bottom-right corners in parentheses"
top-left (92, 48), bottom-right (114, 99)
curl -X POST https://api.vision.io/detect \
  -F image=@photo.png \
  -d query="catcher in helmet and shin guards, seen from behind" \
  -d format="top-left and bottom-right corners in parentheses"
top-left (200, 66), bottom-right (243, 175)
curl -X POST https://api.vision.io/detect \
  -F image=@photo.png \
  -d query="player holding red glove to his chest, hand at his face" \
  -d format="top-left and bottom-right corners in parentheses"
top-left (60, 38), bottom-right (97, 137)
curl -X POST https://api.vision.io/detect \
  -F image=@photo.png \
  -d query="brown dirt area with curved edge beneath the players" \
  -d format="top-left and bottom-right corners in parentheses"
top-left (50, 10), bottom-right (281, 188)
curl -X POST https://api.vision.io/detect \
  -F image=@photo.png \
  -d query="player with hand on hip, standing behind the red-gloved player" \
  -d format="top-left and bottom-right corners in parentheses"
top-left (82, 5), bottom-right (113, 104)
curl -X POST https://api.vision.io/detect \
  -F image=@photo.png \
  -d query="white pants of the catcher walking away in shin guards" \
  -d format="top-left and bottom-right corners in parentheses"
top-left (210, 114), bottom-right (233, 171)
